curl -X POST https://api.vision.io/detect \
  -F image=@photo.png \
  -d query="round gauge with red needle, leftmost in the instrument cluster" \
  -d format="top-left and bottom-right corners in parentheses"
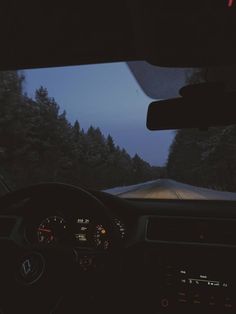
top-left (37, 216), bottom-right (67, 244)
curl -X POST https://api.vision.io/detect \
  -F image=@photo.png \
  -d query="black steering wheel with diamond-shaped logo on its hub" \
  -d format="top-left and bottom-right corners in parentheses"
top-left (0, 183), bottom-right (120, 313)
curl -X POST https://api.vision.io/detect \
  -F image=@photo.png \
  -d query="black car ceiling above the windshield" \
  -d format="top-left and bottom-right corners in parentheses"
top-left (0, 0), bottom-right (236, 70)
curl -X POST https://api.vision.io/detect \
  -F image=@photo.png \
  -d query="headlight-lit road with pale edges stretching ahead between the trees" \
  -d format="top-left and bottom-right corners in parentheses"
top-left (106, 179), bottom-right (236, 200)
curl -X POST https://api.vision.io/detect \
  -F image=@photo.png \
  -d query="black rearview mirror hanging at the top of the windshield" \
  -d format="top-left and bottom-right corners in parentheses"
top-left (147, 84), bottom-right (236, 130)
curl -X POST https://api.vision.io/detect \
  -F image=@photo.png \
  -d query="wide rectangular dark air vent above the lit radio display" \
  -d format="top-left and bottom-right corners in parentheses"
top-left (147, 217), bottom-right (236, 245)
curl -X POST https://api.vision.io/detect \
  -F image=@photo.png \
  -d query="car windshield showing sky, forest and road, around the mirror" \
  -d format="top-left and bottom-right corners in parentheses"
top-left (0, 62), bottom-right (236, 200)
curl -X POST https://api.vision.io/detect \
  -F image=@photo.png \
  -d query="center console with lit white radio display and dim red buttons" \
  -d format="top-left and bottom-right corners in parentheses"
top-left (145, 246), bottom-right (236, 314)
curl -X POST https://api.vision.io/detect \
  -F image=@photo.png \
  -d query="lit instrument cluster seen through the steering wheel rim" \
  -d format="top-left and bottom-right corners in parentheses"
top-left (24, 211), bottom-right (126, 251)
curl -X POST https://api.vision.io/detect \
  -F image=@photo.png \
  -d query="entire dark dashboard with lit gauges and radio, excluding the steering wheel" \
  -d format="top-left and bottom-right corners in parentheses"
top-left (0, 191), bottom-right (236, 313)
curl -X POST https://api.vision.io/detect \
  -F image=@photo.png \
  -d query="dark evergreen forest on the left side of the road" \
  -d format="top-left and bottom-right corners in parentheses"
top-left (0, 71), bottom-right (163, 189)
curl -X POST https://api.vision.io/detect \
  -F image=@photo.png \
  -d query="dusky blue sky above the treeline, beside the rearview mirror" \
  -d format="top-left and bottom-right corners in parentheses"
top-left (24, 63), bottom-right (173, 166)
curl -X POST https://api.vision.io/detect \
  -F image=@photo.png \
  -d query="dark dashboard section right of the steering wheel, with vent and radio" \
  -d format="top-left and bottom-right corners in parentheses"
top-left (92, 196), bottom-right (236, 313)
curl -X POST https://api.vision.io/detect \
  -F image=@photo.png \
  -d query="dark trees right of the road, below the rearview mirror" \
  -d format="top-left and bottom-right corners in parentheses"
top-left (167, 69), bottom-right (236, 192)
